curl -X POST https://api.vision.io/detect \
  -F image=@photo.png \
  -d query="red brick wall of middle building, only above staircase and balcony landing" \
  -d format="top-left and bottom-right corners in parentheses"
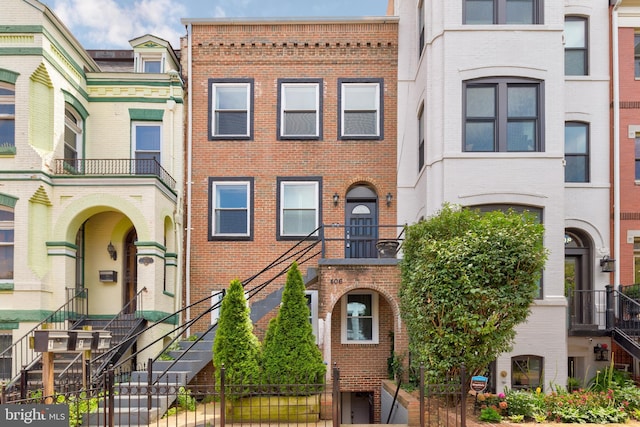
top-left (182, 23), bottom-right (397, 300)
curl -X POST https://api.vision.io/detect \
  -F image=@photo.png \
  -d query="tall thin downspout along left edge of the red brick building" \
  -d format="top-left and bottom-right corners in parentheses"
top-left (184, 23), bottom-right (193, 336)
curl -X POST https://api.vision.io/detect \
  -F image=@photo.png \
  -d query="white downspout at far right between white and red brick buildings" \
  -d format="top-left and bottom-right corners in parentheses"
top-left (611, 0), bottom-right (622, 286)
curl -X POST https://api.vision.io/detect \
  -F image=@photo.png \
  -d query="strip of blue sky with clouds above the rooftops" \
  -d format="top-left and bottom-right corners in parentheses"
top-left (40, 0), bottom-right (388, 49)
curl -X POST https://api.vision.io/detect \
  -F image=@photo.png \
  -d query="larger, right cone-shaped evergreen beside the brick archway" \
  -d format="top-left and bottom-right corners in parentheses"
top-left (262, 263), bottom-right (326, 384)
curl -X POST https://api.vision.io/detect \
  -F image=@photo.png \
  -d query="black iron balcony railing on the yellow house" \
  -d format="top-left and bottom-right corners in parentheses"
top-left (53, 159), bottom-right (176, 191)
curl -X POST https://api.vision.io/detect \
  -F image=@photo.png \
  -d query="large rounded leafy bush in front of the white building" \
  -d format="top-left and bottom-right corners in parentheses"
top-left (400, 205), bottom-right (547, 380)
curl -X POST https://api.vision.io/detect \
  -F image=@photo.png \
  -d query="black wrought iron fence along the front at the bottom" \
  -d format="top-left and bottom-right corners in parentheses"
top-left (0, 367), bottom-right (473, 427)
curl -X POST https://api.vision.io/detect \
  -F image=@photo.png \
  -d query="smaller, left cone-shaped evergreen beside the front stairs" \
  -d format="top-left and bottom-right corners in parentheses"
top-left (213, 280), bottom-right (260, 385)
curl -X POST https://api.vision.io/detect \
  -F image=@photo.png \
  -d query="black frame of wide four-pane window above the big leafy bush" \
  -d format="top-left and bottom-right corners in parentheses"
top-left (462, 77), bottom-right (545, 153)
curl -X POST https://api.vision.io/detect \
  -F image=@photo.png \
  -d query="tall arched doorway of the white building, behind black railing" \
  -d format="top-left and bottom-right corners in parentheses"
top-left (564, 229), bottom-right (595, 325)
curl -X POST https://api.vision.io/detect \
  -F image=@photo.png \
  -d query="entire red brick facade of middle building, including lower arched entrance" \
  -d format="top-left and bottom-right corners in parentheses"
top-left (181, 20), bottom-right (400, 422)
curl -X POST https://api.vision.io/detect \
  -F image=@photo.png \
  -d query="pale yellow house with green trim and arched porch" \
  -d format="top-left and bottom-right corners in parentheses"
top-left (0, 0), bottom-right (184, 386)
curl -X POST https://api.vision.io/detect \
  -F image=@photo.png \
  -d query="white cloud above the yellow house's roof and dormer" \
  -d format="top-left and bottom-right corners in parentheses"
top-left (49, 0), bottom-right (186, 49)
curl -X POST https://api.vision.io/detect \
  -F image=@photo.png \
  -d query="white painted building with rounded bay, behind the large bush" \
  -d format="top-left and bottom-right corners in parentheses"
top-left (394, 0), bottom-right (610, 390)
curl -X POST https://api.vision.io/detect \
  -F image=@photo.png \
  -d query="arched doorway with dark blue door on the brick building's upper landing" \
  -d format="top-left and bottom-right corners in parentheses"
top-left (345, 185), bottom-right (378, 258)
